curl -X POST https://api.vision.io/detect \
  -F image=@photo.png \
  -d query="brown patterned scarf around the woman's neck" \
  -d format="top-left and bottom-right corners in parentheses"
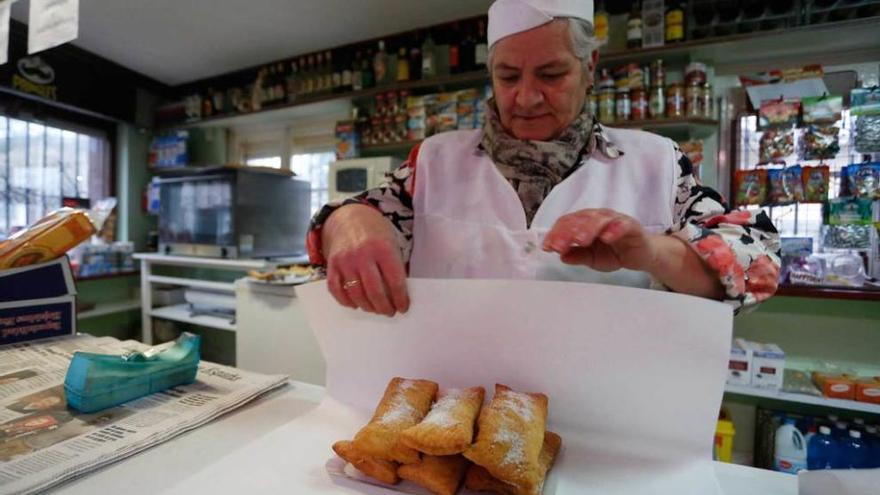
top-left (481, 98), bottom-right (596, 225)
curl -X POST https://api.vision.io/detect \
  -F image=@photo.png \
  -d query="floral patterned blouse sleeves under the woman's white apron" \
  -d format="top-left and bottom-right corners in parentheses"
top-left (308, 123), bottom-right (780, 310)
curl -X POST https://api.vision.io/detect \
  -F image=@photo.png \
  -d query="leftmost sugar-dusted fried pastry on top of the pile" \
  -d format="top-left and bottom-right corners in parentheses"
top-left (354, 377), bottom-right (437, 464)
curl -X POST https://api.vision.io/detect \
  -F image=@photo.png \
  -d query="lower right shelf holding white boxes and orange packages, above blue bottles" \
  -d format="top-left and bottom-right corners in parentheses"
top-left (724, 338), bottom-right (880, 415)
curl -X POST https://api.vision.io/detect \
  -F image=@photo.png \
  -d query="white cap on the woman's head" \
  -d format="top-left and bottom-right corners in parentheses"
top-left (488, 0), bottom-right (593, 46)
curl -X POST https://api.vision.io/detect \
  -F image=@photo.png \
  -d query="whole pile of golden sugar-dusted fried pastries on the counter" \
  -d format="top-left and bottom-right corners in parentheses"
top-left (333, 377), bottom-right (562, 495)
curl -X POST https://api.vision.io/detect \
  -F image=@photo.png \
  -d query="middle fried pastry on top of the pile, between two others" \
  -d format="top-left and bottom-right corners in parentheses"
top-left (400, 387), bottom-right (486, 456)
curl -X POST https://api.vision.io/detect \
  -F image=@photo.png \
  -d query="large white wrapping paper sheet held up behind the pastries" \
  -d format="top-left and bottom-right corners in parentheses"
top-left (297, 280), bottom-right (732, 495)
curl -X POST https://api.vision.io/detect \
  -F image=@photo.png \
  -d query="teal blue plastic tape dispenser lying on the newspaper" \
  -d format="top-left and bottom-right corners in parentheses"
top-left (64, 333), bottom-right (201, 413)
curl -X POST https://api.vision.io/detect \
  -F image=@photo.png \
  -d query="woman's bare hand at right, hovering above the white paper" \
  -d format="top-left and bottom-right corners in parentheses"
top-left (544, 209), bottom-right (658, 272)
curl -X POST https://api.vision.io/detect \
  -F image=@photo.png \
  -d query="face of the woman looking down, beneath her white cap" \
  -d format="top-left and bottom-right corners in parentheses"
top-left (492, 20), bottom-right (596, 141)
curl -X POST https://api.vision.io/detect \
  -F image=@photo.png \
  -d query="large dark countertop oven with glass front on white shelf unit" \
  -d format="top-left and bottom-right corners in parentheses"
top-left (157, 167), bottom-right (311, 258)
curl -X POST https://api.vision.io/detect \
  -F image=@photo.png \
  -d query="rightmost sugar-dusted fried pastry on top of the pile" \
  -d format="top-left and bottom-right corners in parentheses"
top-left (464, 384), bottom-right (547, 491)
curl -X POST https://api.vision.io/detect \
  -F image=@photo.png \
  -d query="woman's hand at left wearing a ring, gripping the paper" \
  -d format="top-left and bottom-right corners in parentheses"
top-left (321, 204), bottom-right (409, 316)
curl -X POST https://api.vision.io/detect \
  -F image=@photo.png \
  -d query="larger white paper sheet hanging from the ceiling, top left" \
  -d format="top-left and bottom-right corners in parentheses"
top-left (28, 0), bottom-right (79, 54)
